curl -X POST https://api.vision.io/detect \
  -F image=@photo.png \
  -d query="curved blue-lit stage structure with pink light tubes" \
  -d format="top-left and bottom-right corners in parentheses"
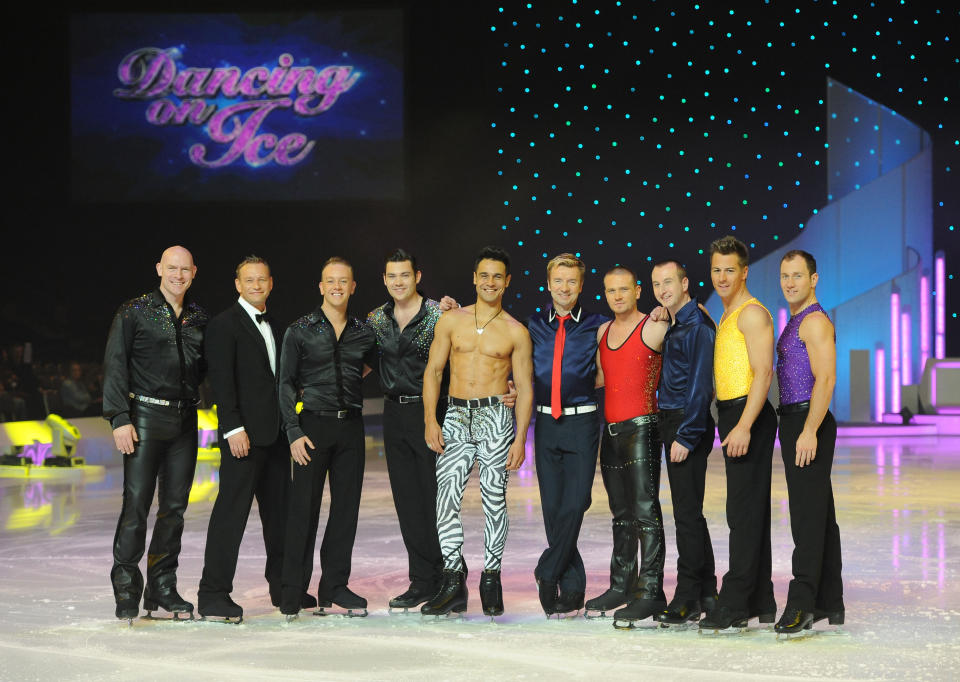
top-left (706, 78), bottom-right (944, 422)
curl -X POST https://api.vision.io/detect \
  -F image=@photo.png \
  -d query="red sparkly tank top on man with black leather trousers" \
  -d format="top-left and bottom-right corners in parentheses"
top-left (600, 315), bottom-right (661, 424)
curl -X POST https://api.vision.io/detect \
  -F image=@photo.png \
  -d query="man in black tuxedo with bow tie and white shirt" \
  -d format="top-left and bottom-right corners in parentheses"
top-left (197, 256), bottom-right (316, 619)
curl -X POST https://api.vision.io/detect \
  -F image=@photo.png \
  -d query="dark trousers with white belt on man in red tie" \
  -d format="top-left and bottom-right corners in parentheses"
top-left (534, 412), bottom-right (600, 592)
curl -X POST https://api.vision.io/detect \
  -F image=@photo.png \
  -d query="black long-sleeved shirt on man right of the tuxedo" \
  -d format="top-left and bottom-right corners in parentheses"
top-left (277, 307), bottom-right (377, 443)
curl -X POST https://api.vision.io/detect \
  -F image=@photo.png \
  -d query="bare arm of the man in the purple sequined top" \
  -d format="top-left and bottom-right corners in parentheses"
top-left (796, 312), bottom-right (837, 467)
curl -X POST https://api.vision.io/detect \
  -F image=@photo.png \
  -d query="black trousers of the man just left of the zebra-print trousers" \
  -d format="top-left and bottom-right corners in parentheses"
top-left (383, 399), bottom-right (446, 589)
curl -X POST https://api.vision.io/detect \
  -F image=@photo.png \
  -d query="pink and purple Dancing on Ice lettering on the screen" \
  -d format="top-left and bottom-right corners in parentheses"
top-left (113, 47), bottom-right (360, 168)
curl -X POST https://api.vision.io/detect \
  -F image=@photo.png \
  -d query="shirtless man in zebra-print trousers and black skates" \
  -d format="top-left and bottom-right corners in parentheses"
top-left (420, 246), bottom-right (533, 616)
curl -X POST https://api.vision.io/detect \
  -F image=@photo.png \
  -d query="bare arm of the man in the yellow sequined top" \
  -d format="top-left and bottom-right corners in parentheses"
top-left (721, 305), bottom-right (773, 457)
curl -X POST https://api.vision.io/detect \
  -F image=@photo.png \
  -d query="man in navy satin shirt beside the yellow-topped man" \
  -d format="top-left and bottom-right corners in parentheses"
top-left (651, 260), bottom-right (717, 625)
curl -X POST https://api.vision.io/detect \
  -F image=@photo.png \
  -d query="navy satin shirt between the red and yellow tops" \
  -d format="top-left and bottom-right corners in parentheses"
top-left (657, 299), bottom-right (717, 450)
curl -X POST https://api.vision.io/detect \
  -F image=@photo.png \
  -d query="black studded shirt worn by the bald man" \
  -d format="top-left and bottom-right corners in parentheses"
top-left (103, 289), bottom-right (207, 428)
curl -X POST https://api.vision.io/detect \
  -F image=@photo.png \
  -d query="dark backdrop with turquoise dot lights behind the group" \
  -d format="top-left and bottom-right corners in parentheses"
top-left (0, 0), bottom-right (960, 360)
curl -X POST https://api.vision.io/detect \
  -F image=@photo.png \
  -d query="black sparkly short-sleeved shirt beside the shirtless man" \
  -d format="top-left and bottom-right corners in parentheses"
top-left (367, 297), bottom-right (442, 396)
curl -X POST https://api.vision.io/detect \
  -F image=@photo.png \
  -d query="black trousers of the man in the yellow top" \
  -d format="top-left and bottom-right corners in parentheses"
top-left (717, 401), bottom-right (777, 614)
